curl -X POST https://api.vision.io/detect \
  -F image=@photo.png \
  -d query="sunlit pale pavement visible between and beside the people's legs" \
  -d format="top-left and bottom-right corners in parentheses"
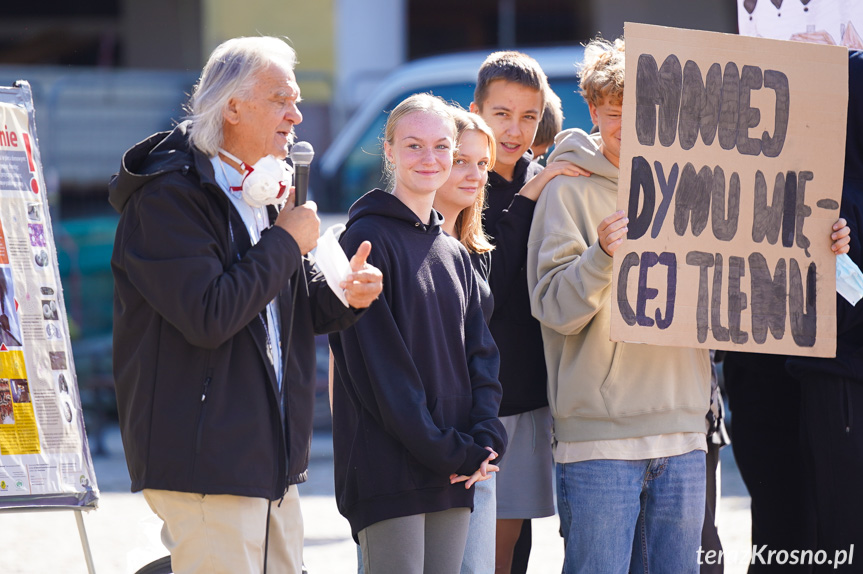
top-left (0, 420), bottom-right (751, 574)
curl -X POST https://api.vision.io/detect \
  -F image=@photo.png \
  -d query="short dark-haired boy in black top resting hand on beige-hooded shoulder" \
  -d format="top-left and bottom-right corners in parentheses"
top-left (470, 52), bottom-right (586, 572)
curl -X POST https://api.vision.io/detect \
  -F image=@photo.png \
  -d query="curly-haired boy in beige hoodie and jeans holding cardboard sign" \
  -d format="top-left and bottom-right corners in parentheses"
top-left (527, 40), bottom-right (710, 574)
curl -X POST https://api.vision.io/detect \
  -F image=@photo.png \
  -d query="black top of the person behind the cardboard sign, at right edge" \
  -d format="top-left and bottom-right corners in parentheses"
top-left (786, 50), bottom-right (863, 383)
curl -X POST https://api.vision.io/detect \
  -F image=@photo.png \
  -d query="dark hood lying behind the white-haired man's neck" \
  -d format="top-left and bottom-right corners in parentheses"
top-left (108, 121), bottom-right (215, 213)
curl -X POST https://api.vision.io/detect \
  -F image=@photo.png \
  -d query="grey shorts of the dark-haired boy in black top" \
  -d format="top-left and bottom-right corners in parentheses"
top-left (496, 407), bottom-right (554, 520)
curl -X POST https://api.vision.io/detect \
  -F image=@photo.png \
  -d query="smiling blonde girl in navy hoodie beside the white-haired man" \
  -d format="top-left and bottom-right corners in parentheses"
top-left (330, 94), bottom-right (506, 574)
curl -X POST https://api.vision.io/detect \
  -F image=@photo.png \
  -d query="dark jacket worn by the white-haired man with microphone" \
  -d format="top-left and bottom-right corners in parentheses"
top-left (109, 122), bottom-right (358, 500)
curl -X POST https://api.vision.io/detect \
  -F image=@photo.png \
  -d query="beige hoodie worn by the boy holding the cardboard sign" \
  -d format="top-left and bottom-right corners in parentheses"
top-left (527, 129), bottom-right (710, 442)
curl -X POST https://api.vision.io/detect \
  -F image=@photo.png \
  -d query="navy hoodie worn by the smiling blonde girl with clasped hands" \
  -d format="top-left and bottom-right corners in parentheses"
top-left (330, 190), bottom-right (506, 538)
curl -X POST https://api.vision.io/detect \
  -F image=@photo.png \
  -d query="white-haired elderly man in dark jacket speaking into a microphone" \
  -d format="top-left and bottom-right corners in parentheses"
top-left (109, 37), bottom-right (381, 574)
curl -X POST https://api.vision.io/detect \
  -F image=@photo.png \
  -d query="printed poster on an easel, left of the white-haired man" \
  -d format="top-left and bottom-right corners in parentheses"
top-left (0, 82), bottom-right (98, 509)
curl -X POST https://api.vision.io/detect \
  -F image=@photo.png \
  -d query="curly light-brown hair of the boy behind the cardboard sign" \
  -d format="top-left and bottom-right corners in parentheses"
top-left (578, 38), bottom-right (625, 106)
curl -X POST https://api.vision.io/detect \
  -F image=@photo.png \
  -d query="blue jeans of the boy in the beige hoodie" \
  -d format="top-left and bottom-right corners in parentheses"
top-left (556, 450), bottom-right (706, 574)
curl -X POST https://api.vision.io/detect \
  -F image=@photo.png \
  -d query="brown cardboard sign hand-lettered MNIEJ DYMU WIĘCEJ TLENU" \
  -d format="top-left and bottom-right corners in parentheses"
top-left (611, 23), bottom-right (848, 357)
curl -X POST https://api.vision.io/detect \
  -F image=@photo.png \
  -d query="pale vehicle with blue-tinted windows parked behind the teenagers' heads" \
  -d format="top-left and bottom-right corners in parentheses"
top-left (312, 46), bottom-right (592, 213)
